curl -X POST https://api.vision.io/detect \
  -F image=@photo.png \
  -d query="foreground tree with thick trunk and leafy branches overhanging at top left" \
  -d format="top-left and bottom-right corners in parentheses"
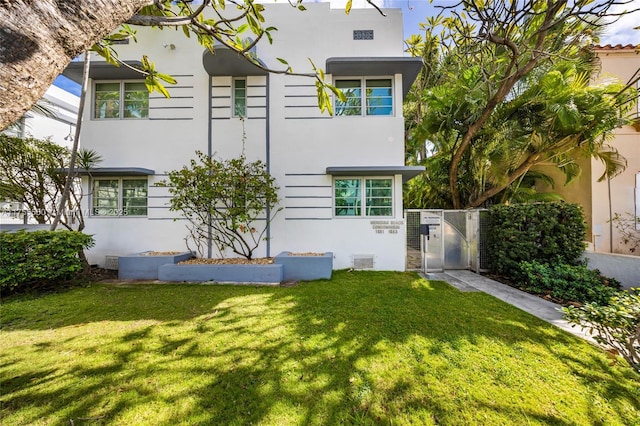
top-left (0, 0), bottom-right (380, 130)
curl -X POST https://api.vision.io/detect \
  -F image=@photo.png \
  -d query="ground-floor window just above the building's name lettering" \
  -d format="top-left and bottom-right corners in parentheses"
top-left (334, 178), bottom-right (393, 217)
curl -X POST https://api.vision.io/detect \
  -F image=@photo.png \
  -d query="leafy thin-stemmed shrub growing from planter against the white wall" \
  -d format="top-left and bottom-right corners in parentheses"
top-left (162, 151), bottom-right (279, 259)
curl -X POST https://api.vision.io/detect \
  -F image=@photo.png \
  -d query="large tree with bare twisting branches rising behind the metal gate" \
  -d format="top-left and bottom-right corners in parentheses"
top-left (407, 0), bottom-right (637, 208)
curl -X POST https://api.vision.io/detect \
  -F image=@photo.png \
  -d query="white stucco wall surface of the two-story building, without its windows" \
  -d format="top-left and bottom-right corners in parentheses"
top-left (77, 4), bottom-right (412, 270)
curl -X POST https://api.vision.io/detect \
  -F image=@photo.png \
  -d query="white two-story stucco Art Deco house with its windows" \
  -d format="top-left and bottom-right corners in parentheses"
top-left (65, 3), bottom-right (423, 270)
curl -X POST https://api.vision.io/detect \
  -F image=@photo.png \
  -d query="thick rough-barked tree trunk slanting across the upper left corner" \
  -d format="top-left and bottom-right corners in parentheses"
top-left (0, 0), bottom-right (153, 130)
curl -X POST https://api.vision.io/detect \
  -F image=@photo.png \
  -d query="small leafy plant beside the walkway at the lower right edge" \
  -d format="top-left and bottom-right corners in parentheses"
top-left (562, 288), bottom-right (640, 371)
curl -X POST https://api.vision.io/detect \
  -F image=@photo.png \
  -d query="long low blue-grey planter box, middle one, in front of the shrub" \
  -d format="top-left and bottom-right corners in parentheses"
top-left (158, 264), bottom-right (284, 284)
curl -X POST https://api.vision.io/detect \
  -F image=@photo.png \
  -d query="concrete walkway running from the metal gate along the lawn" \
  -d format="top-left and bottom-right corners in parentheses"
top-left (423, 270), bottom-right (595, 343)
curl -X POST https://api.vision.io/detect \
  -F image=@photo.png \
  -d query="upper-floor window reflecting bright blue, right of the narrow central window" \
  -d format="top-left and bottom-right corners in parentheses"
top-left (335, 78), bottom-right (393, 116)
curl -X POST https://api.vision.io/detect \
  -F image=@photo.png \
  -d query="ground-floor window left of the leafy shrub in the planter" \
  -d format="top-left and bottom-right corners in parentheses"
top-left (93, 178), bottom-right (147, 216)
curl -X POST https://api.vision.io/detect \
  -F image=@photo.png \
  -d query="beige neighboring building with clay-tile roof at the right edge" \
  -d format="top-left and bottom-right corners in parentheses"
top-left (536, 45), bottom-right (640, 254)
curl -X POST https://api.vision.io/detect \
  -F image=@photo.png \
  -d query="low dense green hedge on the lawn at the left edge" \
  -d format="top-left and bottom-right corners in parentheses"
top-left (0, 231), bottom-right (93, 291)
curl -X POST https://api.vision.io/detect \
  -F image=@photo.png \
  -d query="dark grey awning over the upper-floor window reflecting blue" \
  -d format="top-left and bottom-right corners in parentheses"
top-left (325, 56), bottom-right (422, 98)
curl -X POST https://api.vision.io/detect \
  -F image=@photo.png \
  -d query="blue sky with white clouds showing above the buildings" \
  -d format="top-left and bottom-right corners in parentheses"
top-left (54, 0), bottom-right (640, 96)
